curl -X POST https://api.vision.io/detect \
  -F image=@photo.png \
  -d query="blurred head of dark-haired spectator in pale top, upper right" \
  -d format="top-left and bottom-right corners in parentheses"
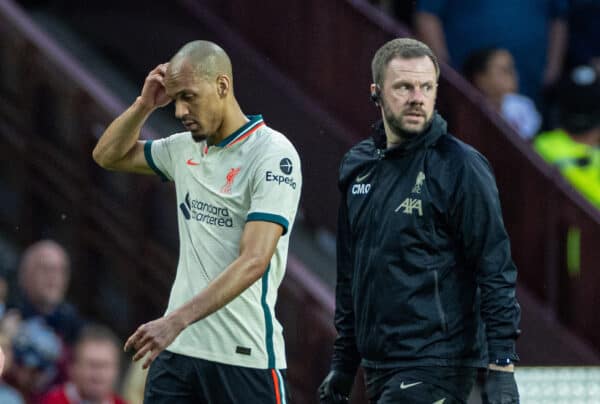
top-left (474, 50), bottom-right (518, 103)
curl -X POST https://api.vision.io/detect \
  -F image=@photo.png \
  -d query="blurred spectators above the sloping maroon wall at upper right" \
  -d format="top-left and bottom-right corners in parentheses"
top-left (372, 0), bottom-right (600, 209)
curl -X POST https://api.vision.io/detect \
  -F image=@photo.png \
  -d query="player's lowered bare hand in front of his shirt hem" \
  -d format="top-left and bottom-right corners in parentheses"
top-left (124, 316), bottom-right (185, 369)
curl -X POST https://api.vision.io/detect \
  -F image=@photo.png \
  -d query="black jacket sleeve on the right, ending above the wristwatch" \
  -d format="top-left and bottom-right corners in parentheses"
top-left (448, 151), bottom-right (521, 362)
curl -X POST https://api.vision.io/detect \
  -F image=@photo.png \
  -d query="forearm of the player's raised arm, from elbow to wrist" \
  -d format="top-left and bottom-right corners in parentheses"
top-left (93, 97), bottom-right (153, 168)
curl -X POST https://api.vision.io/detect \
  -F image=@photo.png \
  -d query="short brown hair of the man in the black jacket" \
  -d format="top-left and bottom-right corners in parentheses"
top-left (371, 38), bottom-right (440, 86)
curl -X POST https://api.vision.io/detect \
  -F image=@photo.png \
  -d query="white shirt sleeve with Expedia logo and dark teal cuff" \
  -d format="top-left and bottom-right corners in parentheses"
top-left (246, 144), bottom-right (302, 234)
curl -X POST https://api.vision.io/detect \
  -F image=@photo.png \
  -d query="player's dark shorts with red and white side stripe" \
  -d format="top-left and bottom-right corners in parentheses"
top-left (144, 351), bottom-right (289, 404)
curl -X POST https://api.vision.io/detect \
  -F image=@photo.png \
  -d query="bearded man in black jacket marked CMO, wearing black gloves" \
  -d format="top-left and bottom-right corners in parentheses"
top-left (319, 38), bottom-right (520, 404)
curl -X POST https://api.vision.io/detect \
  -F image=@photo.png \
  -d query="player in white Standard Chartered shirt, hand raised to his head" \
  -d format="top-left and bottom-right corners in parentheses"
top-left (93, 41), bottom-right (302, 403)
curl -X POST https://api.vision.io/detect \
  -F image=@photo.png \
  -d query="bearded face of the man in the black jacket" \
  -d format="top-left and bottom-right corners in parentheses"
top-left (372, 56), bottom-right (437, 136)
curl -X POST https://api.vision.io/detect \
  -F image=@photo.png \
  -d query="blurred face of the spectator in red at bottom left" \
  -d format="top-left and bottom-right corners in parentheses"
top-left (71, 340), bottom-right (119, 402)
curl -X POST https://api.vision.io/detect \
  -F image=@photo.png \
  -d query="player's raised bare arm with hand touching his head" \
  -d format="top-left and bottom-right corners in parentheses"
top-left (93, 64), bottom-right (171, 174)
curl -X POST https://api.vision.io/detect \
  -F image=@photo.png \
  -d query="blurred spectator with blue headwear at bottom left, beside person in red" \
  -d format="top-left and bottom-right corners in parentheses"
top-left (6, 317), bottom-right (62, 403)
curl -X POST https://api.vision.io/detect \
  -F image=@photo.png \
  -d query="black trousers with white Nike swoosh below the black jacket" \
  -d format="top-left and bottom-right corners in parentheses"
top-left (364, 367), bottom-right (477, 404)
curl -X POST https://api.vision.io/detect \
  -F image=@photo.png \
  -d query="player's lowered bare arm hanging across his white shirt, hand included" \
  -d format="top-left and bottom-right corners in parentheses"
top-left (125, 221), bottom-right (284, 368)
